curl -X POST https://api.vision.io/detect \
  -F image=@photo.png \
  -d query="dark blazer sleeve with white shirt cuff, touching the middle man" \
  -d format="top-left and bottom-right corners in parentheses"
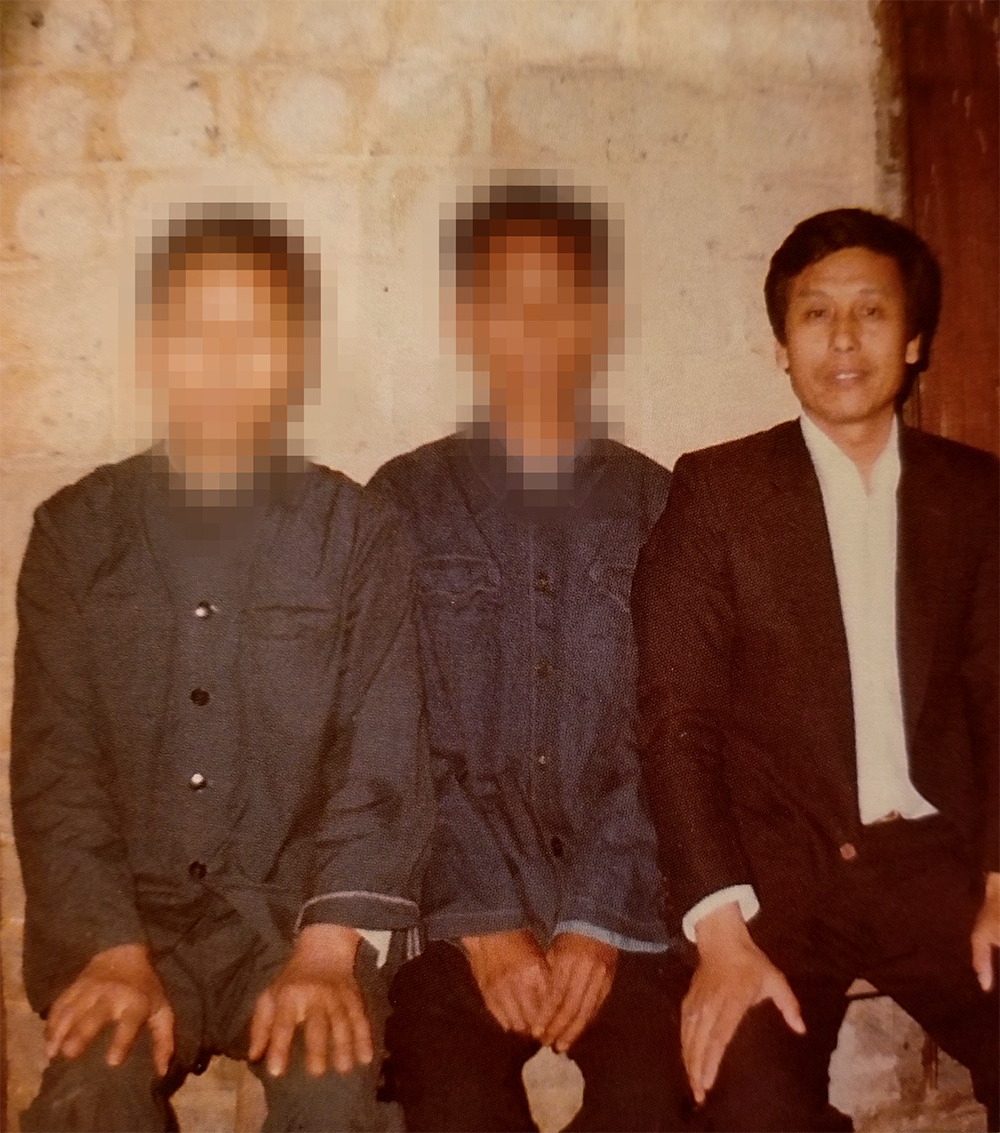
top-left (632, 457), bottom-right (752, 917)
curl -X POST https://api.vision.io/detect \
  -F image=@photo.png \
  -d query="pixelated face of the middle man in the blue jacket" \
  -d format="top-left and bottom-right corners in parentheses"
top-left (458, 221), bottom-right (607, 436)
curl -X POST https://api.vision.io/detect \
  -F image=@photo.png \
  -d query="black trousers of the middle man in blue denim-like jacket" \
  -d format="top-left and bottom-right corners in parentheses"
top-left (386, 942), bottom-right (687, 1133)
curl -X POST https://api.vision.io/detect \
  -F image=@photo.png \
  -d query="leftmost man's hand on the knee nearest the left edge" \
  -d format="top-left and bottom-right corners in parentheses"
top-left (45, 944), bottom-right (173, 1076)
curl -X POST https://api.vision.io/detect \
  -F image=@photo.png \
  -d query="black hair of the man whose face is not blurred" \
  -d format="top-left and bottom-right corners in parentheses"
top-left (764, 208), bottom-right (941, 376)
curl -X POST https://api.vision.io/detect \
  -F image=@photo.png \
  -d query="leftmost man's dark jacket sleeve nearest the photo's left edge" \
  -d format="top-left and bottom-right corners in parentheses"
top-left (10, 505), bottom-right (145, 1013)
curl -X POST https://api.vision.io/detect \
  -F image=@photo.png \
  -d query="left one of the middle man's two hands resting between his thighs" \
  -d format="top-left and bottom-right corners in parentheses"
top-left (462, 929), bottom-right (550, 1038)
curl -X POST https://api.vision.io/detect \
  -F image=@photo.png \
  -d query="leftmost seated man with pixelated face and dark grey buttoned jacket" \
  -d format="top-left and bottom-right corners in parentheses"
top-left (10, 205), bottom-right (433, 1131)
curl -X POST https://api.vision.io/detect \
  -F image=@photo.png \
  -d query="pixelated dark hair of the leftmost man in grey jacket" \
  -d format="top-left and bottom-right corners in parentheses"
top-left (136, 203), bottom-right (319, 324)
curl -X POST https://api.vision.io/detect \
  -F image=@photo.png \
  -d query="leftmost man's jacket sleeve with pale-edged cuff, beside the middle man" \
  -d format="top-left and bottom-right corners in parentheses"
top-left (299, 496), bottom-right (434, 929)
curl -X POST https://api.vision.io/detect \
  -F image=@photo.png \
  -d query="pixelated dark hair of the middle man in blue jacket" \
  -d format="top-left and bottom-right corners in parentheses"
top-left (441, 184), bottom-right (622, 297)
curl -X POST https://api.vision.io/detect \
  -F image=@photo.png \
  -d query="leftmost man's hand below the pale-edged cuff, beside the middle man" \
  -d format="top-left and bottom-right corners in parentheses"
top-left (248, 925), bottom-right (375, 1077)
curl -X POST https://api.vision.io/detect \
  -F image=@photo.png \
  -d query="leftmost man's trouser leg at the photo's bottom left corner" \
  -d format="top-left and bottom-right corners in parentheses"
top-left (20, 1026), bottom-right (178, 1133)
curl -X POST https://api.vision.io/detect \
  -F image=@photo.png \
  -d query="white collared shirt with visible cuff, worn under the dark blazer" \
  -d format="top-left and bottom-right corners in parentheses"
top-left (683, 414), bottom-right (935, 940)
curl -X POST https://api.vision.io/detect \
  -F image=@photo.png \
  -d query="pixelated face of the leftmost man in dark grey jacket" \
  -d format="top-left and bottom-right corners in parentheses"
top-left (146, 254), bottom-right (302, 450)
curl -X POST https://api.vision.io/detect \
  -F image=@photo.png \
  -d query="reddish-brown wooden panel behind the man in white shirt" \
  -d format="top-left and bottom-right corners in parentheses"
top-left (894, 0), bottom-right (1000, 453)
